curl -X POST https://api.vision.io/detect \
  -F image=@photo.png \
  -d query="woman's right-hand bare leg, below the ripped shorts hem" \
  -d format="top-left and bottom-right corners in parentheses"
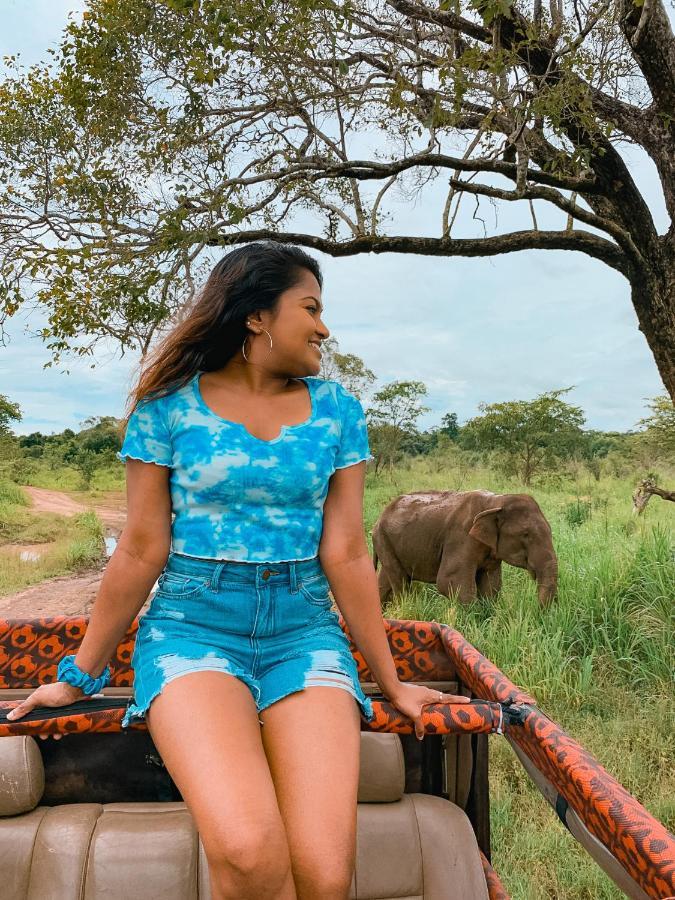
top-left (260, 685), bottom-right (361, 900)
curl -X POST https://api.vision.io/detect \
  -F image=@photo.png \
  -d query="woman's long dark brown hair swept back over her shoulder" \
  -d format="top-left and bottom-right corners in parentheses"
top-left (122, 240), bottom-right (323, 428)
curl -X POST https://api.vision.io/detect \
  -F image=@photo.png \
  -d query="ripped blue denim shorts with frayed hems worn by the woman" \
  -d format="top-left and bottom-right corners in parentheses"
top-left (122, 552), bottom-right (374, 728)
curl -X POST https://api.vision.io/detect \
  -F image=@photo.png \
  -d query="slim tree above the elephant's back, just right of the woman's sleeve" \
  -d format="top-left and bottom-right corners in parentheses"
top-left (366, 381), bottom-right (430, 474)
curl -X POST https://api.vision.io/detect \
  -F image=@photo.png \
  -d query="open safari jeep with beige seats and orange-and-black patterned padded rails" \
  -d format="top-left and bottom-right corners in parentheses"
top-left (0, 616), bottom-right (675, 900)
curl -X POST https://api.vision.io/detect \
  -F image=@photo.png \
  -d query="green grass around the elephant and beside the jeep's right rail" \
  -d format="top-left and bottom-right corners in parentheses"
top-left (374, 467), bottom-right (675, 900)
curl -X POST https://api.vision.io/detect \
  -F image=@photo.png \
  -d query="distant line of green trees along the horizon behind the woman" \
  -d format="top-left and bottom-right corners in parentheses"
top-left (0, 368), bottom-right (675, 488)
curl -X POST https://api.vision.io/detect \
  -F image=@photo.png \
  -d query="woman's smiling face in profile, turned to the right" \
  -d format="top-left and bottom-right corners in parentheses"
top-left (255, 269), bottom-right (330, 376)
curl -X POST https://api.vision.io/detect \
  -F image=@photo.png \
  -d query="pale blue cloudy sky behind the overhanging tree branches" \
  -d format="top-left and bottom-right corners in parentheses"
top-left (0, 0), bottom-right (667, 434)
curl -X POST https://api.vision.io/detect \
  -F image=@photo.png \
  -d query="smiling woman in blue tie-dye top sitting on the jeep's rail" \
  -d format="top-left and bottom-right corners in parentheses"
top-left (7, 242), bottom-right (467, 900)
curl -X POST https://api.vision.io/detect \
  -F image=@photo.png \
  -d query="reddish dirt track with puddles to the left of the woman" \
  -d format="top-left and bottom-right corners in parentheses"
top-left (0, 487), bottom-right (133, 619)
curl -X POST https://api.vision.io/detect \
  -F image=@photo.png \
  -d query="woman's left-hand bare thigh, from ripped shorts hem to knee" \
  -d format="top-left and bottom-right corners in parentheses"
top-left (146, 671), bottom-right (288, 868)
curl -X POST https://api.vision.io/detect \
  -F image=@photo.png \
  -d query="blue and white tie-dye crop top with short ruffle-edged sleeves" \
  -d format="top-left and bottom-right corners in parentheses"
top-left (117, 373), bottom-right (374, 563)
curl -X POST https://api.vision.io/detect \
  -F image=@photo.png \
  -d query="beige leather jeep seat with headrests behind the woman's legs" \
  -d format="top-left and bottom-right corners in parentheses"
top-left (0, 732), bottom-right (488, 900)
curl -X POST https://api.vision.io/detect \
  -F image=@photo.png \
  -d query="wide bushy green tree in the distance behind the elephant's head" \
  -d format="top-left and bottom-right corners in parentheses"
top-left (462, 388), bottom-right (584, 485)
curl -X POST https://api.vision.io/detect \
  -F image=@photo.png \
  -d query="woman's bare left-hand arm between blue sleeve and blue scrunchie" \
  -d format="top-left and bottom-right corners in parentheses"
top-left (70, 459), bottom-right (171, 678)
